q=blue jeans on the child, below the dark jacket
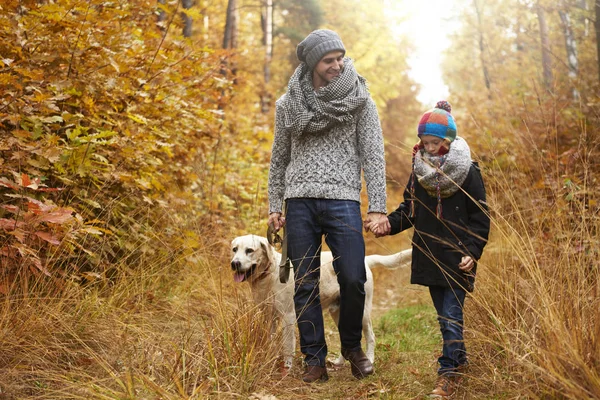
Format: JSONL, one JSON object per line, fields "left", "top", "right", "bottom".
{"left": 429, "top": 286, "right": 467, "bottom": 375}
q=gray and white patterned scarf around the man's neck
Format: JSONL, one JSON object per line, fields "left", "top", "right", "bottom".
{"left": 283, "top": 57, "right": 369, "bottom": 134}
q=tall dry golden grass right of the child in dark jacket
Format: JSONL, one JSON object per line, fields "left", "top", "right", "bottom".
{"left": 466, "top": 115, "right": 600, "bottom": 399}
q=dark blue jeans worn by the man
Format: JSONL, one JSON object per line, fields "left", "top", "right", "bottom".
{"left": 286, "top": 198, "right": 367, "bottom": 366}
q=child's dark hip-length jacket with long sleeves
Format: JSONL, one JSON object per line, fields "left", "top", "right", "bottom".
{"left": 388, "top": 163, "right": 490, "bottom": 291}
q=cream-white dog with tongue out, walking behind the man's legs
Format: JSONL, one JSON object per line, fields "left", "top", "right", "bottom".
{"left": 231, "top": 235, "right": 412, "bottom": 368}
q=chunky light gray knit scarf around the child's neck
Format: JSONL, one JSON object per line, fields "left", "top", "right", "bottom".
{"left": 414, "top": 137, "right": 471, "bottom": 198}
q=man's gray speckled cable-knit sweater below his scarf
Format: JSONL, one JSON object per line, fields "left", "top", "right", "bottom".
{"left": 269, "top": 94, "right": 386, "bottom": 213}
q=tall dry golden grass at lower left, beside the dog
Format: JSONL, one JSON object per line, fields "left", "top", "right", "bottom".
{"left": 0, "top": 217, "right": 286, "bottom": 399}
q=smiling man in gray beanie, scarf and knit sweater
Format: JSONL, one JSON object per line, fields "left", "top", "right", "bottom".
{"left": 269, "top": 29, "right": 386, "bottom": 382}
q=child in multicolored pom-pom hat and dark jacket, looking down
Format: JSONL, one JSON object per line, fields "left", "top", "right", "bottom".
{"left": 366, "top": 101, "right": 490, "bottom": 397}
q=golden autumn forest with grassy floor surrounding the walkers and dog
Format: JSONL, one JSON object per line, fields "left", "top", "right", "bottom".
{"left": 0, "top": 0, "right": 600, "bottom": 400}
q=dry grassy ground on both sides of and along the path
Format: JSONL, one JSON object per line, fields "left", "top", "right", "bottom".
{"left": 0, "top": 137, "right": 600, "bottom": 399}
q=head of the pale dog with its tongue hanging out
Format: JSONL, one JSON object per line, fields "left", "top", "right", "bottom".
{"left": 231, "top": 235, "right": 273, "bottom": 282}
